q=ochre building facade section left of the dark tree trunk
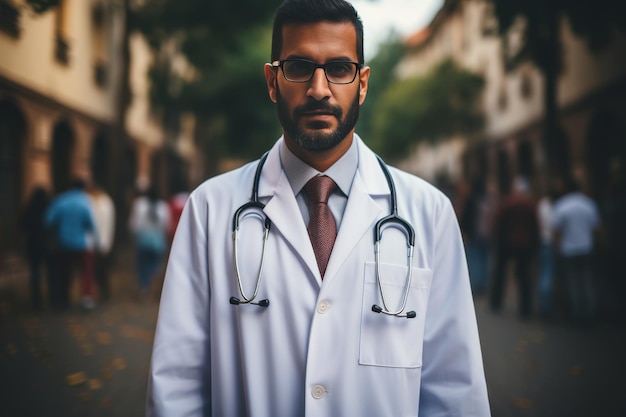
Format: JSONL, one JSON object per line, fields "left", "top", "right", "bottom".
{"left": 0, "top": 0, "right": 124, "bottom": 252}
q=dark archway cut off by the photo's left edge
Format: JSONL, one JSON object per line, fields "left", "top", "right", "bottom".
{"left": 0, "top": 100, "right": 26, "bottom": 253}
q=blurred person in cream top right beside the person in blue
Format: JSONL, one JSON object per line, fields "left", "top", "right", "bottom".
{"left": 89, "top": 184, "right": 115, "bottom": 300}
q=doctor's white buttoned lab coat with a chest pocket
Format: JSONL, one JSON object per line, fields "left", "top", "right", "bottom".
{"left": 148, "top": 135, "right": 490, "bottom": 417}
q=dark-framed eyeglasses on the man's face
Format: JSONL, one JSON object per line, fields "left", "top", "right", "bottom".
{"left": 272, "top": 59, "right": 363, "bottom": 84}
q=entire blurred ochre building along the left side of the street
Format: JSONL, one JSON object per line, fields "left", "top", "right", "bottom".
{"left": 0, "top": 0, "right": 203, "bottom": 262}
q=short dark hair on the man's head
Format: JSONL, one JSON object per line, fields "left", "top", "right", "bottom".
{"left": 271, "top": 0, "right": 365, "bottom": 64}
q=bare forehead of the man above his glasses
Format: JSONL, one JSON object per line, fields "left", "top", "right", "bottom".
{"left": 280, "top": 22, "right": 358, "bottom": 62}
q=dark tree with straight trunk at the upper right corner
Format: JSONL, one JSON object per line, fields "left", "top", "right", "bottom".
{"left": 491, "top": 0, "right": 626, "bottom": 176}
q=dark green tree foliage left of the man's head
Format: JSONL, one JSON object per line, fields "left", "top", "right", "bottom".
{"left": 132, "top": 0, "right": 280, "bottom": 158}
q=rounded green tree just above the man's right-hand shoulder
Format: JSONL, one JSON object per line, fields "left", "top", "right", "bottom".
{"left": 372, "top": 60, "right": 484, "bottom": 158}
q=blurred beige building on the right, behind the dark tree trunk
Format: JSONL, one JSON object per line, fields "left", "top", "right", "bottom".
{"left": 398, "top": 0, "right": 626, "bottom": 196}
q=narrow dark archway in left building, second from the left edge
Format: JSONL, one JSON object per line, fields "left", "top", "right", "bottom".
{"left": 52, "top": 121, "right": 75, "bottom": 194}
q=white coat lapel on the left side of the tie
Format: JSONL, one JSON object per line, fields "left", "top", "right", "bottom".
{"left": 259, "top": 140, "right": 321, "bottom": 284}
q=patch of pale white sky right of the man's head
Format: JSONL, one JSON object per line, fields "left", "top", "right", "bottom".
{"left": 351, "top": 0, "right": 443, "bottom": 60}
